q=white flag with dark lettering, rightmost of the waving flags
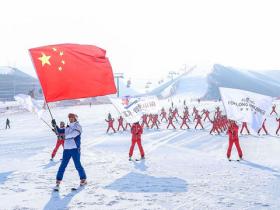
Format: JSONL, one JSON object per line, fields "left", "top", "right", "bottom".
{"left": 219, "top": 87, "right": 272, "bottom": 131}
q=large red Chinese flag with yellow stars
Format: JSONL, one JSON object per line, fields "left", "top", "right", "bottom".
{"left": 29, "top": 44, "right": 117, "bottom": 102}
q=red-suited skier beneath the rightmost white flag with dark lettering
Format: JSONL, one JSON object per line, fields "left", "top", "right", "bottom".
{"left": 227, "top": 120, "right": 243, "bottom": 161}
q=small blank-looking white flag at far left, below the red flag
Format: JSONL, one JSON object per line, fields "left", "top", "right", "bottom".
{"left": 14, "top": 94, "right": 45, "bottom": 119}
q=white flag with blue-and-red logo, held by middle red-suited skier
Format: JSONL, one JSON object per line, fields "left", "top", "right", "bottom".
{"left": 110, "top": 96, "right": 160, "bottom": 123}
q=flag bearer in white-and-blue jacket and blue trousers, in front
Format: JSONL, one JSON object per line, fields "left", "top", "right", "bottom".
{"left": 52, "top": 113, "right": 87, "bottom": 190}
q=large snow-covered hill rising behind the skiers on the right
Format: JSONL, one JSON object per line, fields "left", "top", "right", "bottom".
{"left": 143, "top": 64, "right": 280, "bottom": 100}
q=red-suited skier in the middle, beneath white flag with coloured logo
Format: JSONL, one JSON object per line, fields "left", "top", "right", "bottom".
{"left": 129, "top": 122, "right": 145, "bottom": 161}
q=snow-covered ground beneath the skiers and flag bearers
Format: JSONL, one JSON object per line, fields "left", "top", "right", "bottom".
{"left": 0, "top": 102, "right": 280, "bottom": 210}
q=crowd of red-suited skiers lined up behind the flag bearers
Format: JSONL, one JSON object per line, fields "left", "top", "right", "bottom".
{"left": 105, "top": 105, "right": 280, "bottom": 135}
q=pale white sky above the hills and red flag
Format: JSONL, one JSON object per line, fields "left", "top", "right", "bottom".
{"left": 0, "top": 0, "right": 280, "bottom": 82}
